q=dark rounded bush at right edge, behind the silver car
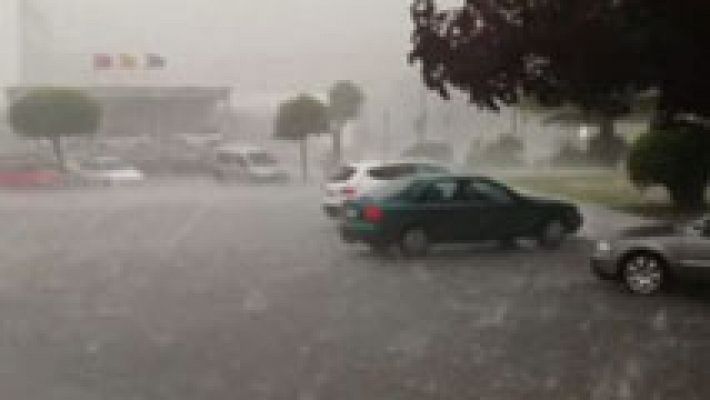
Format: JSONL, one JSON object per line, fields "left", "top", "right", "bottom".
{"left": 628, "top": 123, "right": 710, "bottom": 210}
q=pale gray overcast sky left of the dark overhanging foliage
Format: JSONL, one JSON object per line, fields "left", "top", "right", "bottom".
{"left": 33, "top": 0, "right": 464, "bottom": 98}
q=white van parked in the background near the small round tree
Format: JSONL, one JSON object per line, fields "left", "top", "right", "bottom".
{"left": 213, "top": 145, "right": 290, "bottom": 182}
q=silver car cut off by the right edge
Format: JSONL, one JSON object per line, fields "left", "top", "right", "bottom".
{"left": 591, "top": 217, "right": 710, "bottom": 295}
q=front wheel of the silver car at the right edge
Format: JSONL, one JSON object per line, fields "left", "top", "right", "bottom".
{"left": 621, "top": 253, "right": 666, "bottom": 295}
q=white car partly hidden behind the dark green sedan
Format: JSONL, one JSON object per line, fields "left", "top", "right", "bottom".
{"left": 323, "top": 160, "right": 450, "bottom": 218}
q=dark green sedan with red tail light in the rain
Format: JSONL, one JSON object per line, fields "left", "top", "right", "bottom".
{"left": 340, "top": 175, "right": 582, "bottom": 255}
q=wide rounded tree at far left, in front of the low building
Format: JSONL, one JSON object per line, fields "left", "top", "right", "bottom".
{"left": 8, "top": 88, "right": 101, "bottom": 169}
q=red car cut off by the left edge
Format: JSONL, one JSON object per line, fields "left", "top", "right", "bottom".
{"left": 0, "top": 159, "right": 64, "bottom": 188}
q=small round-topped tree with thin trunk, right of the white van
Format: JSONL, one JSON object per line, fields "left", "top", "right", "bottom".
{"left": 274, "top": 94, "right": 329, "bottom": 182}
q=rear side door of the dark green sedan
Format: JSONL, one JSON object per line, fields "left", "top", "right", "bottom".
{"left": 410, "top": 178, "right": 466, "bottom": 242}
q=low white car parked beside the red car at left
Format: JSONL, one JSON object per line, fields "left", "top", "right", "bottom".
{"left": 68, "top": 157, "right": 145, "bottom": 186}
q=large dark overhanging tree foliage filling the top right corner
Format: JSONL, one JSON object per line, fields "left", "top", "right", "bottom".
{"left": 410, "top": 0, "right": 710, "bottom": 163}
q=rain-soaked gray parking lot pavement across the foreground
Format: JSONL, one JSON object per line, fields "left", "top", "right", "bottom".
{"left": 0, "top": 180, "right": 710, "bottom": 400}
